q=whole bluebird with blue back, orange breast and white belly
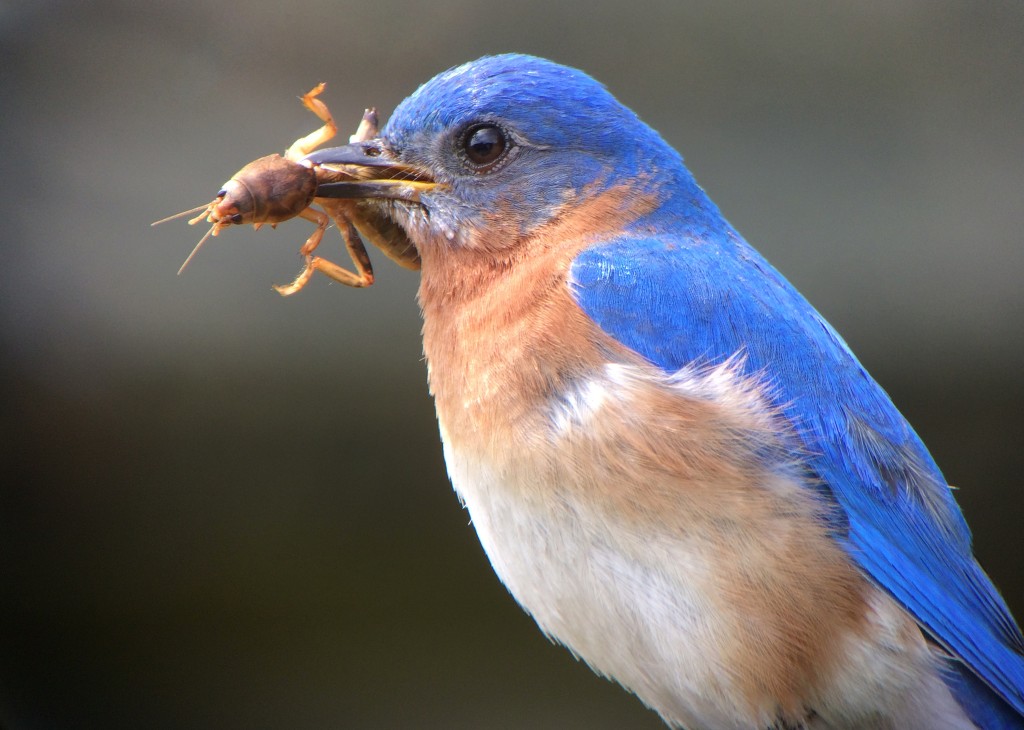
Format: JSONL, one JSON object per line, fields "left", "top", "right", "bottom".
{"left": 307, "top": 55, "right": 1024, "bottom": 730}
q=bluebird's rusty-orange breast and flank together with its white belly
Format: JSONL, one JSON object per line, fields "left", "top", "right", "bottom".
{"left": 413, "top": 241, "right": 880, "bottom": 728}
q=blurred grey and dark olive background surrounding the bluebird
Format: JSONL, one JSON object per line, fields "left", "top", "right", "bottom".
{"left": 0, "top": 0, "right": 1024, "bottom": 729}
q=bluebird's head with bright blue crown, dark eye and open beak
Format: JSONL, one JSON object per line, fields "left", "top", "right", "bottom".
{"left": 307, "top": 54, "right": 711, "bottom": 250}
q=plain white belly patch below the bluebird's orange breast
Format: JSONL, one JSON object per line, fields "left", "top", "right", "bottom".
{"left": 444, "top": 417, "right": 728, "bottom": 727}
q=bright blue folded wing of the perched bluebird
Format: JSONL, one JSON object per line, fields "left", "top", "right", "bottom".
{"left": 570, "top": 230, "right": 1024, "bottom": 726}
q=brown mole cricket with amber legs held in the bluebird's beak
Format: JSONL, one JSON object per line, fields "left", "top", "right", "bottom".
{"left": 152, "top": 83, "right": 420, "bottom": 296}
